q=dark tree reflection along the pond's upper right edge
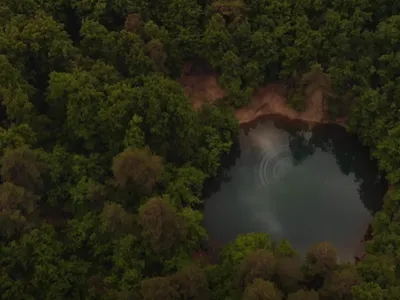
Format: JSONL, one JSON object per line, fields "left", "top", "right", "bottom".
{"left": 260, "top": 118, "right": 388, "bottom": 214}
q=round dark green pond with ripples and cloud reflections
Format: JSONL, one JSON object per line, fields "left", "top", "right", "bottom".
{"left": 205, "top": 118, "right": 387, "bottom": 260}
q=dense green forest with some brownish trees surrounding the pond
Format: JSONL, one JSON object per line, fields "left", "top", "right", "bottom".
{"left": 0, "top": 0, "right": 400, "bottom": 300}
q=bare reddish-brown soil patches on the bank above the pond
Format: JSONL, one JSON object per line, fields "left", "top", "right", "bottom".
{"left": 178, "top": 67, "right": 345, "bottom": 126}
